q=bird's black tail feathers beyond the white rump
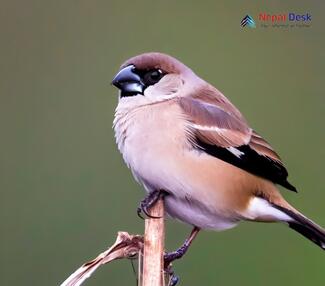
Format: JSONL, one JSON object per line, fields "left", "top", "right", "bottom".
{"left": 273, "top": 204, "right": 325, "bottom": 250}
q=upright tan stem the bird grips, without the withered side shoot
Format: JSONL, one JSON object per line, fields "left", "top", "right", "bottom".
{"left": 141, "top": 198, "right": 165, "bottom": 286}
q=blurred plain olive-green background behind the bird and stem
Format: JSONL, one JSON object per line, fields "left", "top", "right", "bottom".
{"left": 0, "top": 0, "right": 325, "bottom": 286}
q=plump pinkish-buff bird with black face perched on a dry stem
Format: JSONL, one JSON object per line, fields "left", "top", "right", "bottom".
{"left": 112, "top": 52, "right": 325, "bottom": 265}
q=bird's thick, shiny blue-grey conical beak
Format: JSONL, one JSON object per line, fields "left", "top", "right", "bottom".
{"left": 112, "top": 65, "right": 144, "bottom": 95}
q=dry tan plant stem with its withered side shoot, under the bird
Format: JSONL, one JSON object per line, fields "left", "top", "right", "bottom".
{"left": 60, "top": 198, "right": 165, "bottom": 286}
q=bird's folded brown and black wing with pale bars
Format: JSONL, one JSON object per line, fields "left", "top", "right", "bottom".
{"left": 178, "top": 93, "right": 296, "bottom": 191}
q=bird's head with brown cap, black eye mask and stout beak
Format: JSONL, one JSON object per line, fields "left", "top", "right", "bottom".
{"left": 112, "top": 53, "right": 195, "bottom": 101}
